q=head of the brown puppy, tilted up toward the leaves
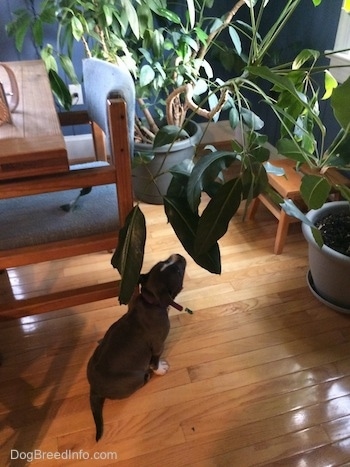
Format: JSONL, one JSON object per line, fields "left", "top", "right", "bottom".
{"left": 140, "top": 254, "right": 186, "bottom": 307}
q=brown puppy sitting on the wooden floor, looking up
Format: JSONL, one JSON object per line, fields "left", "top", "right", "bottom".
{"left": 87, "top": 254, "right": 186, "bottom": 441}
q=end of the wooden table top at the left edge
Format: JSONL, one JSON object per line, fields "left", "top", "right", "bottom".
{"left": 0, "top": 60, "right": 69, "bottom": 180}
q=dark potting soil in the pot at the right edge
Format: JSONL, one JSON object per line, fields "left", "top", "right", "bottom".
{"left": 316, "top": 212, "right": 350, "bottom": 256}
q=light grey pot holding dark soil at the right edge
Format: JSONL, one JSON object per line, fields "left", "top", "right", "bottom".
{"left": 302, "top": 201, "right": 350, "bottom": 313}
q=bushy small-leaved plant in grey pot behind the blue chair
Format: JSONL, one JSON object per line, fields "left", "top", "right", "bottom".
{"left": 7, "top": 0, "right": 242, "bottom": 203}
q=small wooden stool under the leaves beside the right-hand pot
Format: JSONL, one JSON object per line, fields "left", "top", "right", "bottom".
{"left": 248, "top": 159, "right": 302, "bottom": 255}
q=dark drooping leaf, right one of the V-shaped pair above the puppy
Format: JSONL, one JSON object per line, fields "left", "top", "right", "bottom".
{"left": 195, "top": 179, "right": 242, "bottom": 255}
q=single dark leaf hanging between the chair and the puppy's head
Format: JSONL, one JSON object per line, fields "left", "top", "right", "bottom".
{"left": 111, "top": 205, "right": 146, "bottom": 304}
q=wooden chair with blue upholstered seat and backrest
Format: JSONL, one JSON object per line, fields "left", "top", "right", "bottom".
{"left": 0, "top": 59, "right": 135, "bottom": 320}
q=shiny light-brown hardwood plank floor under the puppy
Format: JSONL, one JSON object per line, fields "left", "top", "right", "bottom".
{"left": 0, "top": 199, "right": 350, "bottom": 467}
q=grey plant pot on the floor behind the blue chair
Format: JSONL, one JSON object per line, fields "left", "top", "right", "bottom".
{"left": 133, "top": 121, "right": 202, "bottom": 204}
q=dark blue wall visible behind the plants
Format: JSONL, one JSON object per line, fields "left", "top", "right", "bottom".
{"left": 0, "top": 0, "right": 342, "bottom": 142}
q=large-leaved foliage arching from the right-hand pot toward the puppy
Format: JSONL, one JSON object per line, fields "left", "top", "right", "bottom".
{"left": 112, "top": 0, "right": 350, "bottom": 302}
